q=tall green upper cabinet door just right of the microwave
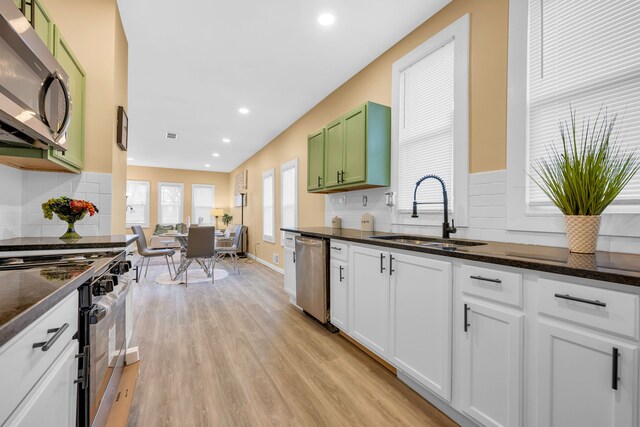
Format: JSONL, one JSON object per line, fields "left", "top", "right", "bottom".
{"left": 51, "top": 27, "right": 86, "bottom": 170}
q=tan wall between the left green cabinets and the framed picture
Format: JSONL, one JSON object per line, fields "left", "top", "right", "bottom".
{"left": 44, "top": 0, "right": 129, "bottom": 232}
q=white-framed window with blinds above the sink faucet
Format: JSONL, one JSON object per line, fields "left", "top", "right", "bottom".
{"left": 392, "top": 15, "right": 469, "bottom": 225}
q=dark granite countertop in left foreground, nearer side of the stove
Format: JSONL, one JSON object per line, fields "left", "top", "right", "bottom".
{"left": 0, "top": 263, "right": 94, "bottom": 346}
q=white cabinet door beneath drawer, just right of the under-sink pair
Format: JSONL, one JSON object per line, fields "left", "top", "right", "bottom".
{"left": 460, "top": 299, "right": 524, "bottom": 427}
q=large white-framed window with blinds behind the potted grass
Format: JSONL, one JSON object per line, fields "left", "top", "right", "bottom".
{"left": 507, "top": 0, "right": 640, "bottom": 234}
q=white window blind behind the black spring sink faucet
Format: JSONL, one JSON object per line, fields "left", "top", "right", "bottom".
{"left": 398, "top": 40, "right": 455, "bottom": 211}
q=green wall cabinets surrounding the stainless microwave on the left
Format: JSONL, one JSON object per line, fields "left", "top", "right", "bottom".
{"left": 0, "top": 0, "right": 86, "bottom": 173}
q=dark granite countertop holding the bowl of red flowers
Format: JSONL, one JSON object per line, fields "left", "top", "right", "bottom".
{"left": 0, "top": 234, "right": 136, "bottom": 256}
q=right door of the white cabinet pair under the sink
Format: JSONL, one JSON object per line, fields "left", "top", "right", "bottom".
{"left": 389, "top": 252, "right": 452, "bottom": 400}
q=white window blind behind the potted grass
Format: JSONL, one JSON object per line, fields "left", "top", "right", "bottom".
{"left": 527, "top": 0, "right": 640, "bottom": 206}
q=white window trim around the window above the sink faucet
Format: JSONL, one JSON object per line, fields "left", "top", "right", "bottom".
{"left": 391, "top": 14, "right": 470, "bottom": 227}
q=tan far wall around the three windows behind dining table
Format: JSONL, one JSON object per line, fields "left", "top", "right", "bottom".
{"left": 125, "top": 166, "right": 231, "bottom": 238}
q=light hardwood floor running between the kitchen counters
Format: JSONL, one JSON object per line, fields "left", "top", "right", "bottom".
{"left": 129, "top": 262, "right": 456, "bottom": 427}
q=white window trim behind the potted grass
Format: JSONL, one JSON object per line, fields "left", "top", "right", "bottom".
{"left": 506, "top": 0, "right": 640, "bottom": 237}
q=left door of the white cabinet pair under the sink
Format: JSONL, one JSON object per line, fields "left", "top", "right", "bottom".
{"left": 349, "top": 246, "right": 389, "bottom": 359}
